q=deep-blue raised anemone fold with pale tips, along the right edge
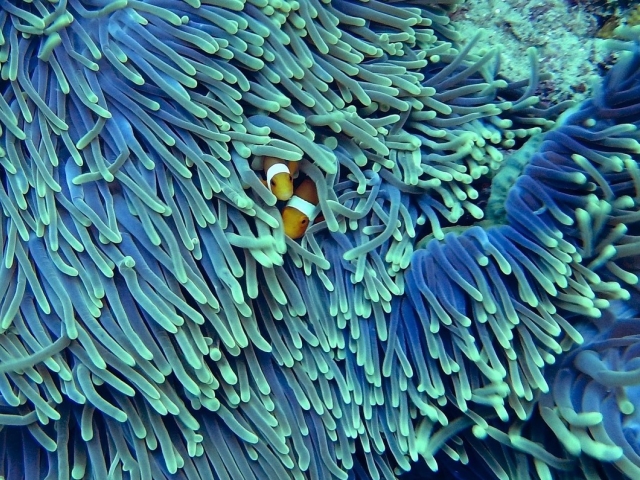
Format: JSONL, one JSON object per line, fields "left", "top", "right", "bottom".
{"left": 402, "top": 38, "right": 640, "bottom": 479}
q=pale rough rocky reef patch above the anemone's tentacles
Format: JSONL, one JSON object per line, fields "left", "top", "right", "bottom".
{"left": 452, "top": 0, "right": 611, "bottom": 102}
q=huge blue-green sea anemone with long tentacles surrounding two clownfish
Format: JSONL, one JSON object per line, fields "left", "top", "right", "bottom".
{"left": 0, "top": 0, "right": 640, "bottom": 480}
